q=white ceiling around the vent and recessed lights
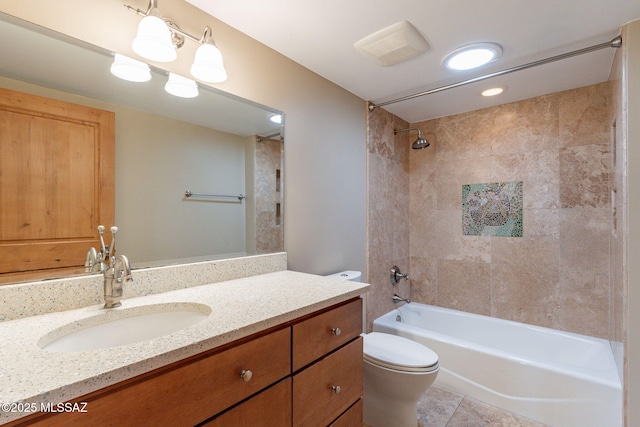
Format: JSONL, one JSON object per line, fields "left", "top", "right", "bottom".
{"left": 187, "top": 0, "right": 640, "bottom": 122}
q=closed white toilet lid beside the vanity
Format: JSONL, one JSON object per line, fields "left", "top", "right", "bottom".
{"left": 364, "top": 332, "right": 438, "bottom": 372}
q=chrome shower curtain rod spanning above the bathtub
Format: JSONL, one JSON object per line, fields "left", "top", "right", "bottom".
{"left": 369, "top": 36, "right": 622, "bottom": 111}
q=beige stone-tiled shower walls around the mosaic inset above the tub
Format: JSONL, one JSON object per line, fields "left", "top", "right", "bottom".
{"left": 368, "top": 83, "right": 612, "bottom": 338}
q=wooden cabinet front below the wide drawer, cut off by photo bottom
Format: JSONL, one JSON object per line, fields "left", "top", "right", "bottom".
{"left": 203, "top": 378, "right": 292, "bottom": 427}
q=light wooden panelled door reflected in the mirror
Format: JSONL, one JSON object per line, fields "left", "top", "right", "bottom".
{"left": 0, "top": 88, "right": 115, "bottom": 283}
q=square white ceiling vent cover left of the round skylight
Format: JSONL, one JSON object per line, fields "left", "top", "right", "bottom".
{"left": 354, "top": 21, "right": 431, "bottom": 67}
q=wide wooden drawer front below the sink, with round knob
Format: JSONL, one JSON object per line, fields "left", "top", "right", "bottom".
{"left": 20, "top": 327, "right": 291, "bottom": 427}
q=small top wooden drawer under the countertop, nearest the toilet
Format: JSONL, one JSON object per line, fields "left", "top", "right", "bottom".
{"left": 293, "top": 298, "right": 362, "bottom": 372}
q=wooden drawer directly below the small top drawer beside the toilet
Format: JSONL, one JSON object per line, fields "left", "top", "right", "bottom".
{"left": 293, "top": 337, "right": 362, "bottom": 427}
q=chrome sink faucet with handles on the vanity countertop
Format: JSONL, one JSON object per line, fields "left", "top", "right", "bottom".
{"left": 97, "top": 226, "right": 133, "bottom": 308}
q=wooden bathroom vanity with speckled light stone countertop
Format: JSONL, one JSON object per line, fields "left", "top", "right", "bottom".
{"left": 0, "top": 271, "right": 368, "bottom": 427}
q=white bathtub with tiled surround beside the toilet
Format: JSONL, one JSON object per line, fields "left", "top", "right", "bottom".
{"left": 373, "top": 303, "right": 622, "bottom": 427}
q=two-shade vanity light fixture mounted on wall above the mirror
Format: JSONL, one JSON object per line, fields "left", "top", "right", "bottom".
{"left": 125, "top": 0, "right": 227, "bottom": 83}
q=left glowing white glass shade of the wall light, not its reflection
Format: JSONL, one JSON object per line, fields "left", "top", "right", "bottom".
{"left": 131, "top": 15, "right": 178, "bottom": 62}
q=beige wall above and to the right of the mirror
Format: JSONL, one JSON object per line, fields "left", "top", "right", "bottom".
{"left": 0, "top": 0, "right": 366, "bottom": 274}
